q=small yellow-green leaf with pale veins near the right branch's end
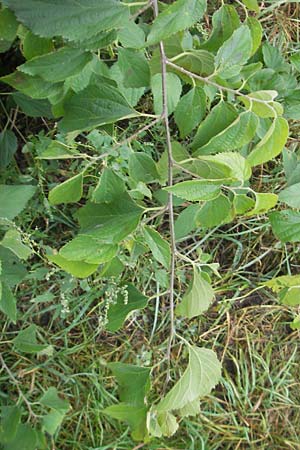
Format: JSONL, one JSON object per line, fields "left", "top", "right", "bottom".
{"left": 239, "top": 91, "right": 283, "bottom": 118}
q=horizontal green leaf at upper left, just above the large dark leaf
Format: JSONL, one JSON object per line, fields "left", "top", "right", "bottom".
{"left": 18, "top": 47, "right": 92, "bottom": 83}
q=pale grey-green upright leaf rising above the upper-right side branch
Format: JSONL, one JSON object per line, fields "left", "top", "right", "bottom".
{"left": 215, "top": 25, "right": 252, "bottom": 78}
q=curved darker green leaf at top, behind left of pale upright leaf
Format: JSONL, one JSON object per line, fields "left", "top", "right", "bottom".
{"left": 201, "top": 5, "right": 240, "bottom": 52}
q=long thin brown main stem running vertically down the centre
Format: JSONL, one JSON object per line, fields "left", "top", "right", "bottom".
{"left": 153, "top": 0, "right": 176, "bottom": 382}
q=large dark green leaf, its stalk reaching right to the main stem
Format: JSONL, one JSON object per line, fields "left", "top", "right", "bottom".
{"left": 60, "top": 80, "right": 139, "bottom": 133}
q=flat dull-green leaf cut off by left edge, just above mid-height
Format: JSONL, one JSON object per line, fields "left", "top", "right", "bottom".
{"left": 0, "top": 184, "right": 36, "bottom": 220}
